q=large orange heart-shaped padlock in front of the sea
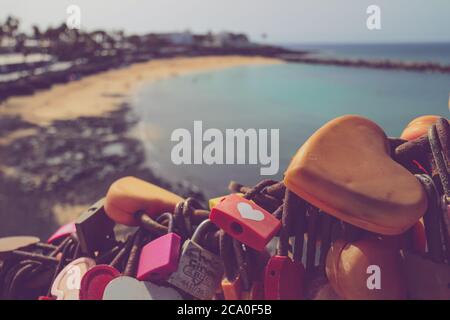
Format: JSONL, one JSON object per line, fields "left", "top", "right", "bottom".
{"left": 284, "top": 115, "right": 427, "bottom": 235}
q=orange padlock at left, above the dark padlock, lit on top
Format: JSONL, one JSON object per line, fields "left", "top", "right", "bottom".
{"left": 105, "top": 177, "right": 183, "bottom": 226}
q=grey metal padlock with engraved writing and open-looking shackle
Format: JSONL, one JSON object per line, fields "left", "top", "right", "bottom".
{"left": 167, "top": 220, "right": 224, "bottom": 300}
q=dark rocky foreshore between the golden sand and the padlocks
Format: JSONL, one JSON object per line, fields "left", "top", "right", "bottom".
{"left": 0, "top": 105, "right": 201, "bottom": 237}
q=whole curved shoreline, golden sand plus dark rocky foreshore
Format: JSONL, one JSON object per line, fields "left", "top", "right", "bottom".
{"left": 0, "top": 56, "right": 283, "bottom": 237}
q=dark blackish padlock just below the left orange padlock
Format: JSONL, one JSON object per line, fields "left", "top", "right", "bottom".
{"left": 75, "top": 199, "right": 115, "bottom": 257}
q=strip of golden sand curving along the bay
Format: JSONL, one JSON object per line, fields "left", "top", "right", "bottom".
{"left": 0, "top": 56, "right": 282, "bottom": 127}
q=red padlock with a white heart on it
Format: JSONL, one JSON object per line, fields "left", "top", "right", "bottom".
{"left": 210, "top": 194, "right": 281, "bottom": 251}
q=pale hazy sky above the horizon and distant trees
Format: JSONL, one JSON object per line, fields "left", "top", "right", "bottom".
{"left": 0, "top": 0, "right": 450, "bottom": 43}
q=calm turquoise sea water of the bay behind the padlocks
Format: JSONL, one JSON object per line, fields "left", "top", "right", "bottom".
{"left": 134, "top": 64, "right": 450, "bottom": 195}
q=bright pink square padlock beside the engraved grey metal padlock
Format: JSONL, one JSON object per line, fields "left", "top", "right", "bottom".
{"left": 136, "top": 212, "right": 181, "bottom": 281}
